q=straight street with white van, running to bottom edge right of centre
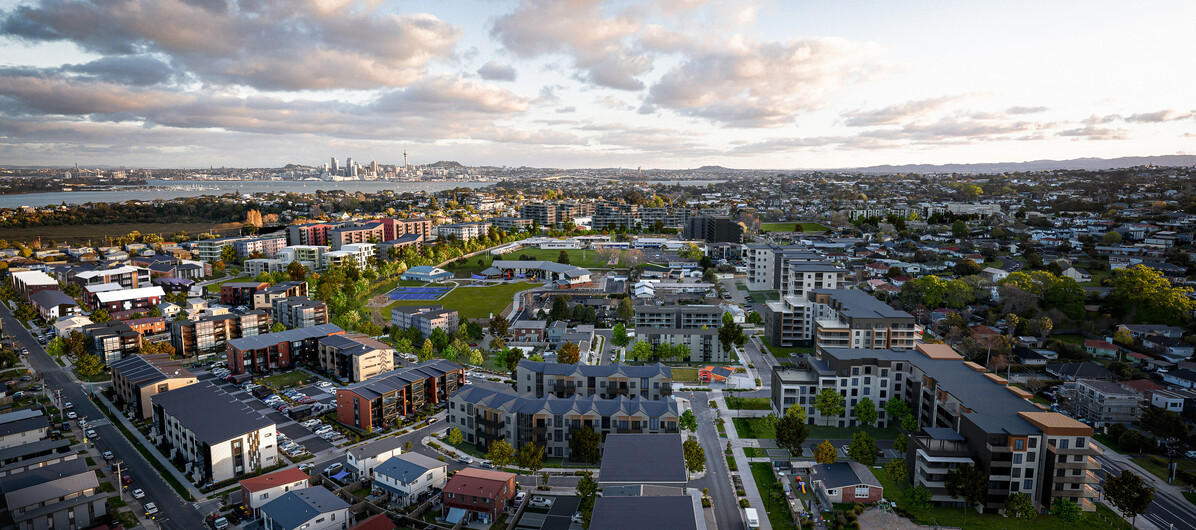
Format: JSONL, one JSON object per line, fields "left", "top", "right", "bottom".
{"left": 690, "top": 392, "right": 752, "bottom": 529}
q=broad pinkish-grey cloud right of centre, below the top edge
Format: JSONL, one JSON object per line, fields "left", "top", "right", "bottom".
{"left": 645, "top": 37, "right": 878, "bottom": 127}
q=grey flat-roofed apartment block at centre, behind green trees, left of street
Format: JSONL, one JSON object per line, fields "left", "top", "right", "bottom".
{"left": 634, "top": 304, "right": 731, "bottom": 363}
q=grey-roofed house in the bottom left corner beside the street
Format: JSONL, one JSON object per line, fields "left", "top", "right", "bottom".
{"left": 0, "top": 458, "right": 115, "bottom": 530}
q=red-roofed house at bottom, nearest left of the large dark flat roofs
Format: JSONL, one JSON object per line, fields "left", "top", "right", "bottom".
{"left": 440, "top": 468, "right": 515, "bottom": 524}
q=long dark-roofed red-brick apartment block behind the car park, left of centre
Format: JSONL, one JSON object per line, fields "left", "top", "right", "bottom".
{"left": 227, "top": 324, "right": 344, "bottom": 374}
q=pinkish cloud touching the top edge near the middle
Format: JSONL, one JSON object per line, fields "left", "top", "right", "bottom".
{"left": 490, "top": 0, "right": 652, "bottom": 90}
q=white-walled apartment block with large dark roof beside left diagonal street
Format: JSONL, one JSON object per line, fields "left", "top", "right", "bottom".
{"left": 150, "top": 380, "right": 279, "bottom": 483}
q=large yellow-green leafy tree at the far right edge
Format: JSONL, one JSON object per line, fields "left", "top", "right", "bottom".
{"left": 1112, "top": 264, "right": 1196, "bottom": 324}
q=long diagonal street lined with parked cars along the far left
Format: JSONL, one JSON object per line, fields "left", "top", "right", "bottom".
{"left": 0, "top": 304, "right": 218, "bottom": 529}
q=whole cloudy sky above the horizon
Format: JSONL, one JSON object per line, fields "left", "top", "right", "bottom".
{"left": 0, "top": 0, "right": 1196, "bottom": 169}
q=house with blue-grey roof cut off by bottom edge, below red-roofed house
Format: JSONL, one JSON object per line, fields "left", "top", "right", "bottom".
{"left": 261, "top": 486, "right": 353, "bottom": 530}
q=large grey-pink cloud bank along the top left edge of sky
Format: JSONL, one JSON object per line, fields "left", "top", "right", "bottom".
{"left": 0, "top": 0, "right": 462, "bottom": 91}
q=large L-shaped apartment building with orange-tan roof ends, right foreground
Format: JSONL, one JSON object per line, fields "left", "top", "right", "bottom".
{"left": 771, "top": 343, "right": 1099, "bottom": 511}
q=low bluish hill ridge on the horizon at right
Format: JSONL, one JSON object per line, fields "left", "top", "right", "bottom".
{"left": 853, "top": 154, "right": 1196, "bottom": 173}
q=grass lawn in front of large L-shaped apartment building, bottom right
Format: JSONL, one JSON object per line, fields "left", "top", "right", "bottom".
{"left": 874, "top": 473, "right": 1130, "bottom": 530}
